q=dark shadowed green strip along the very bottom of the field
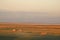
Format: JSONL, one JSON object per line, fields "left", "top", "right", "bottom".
{"left": 0, "top": 32, "right": 60, "bottom": 40}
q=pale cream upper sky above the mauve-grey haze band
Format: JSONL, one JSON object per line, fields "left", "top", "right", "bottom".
{"left": 0, "top": 0, "right": 60, "bottom": 12}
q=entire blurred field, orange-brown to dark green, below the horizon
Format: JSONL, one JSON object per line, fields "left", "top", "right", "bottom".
{"left": 0, "top": 23, "right": 60, "bottom": 40}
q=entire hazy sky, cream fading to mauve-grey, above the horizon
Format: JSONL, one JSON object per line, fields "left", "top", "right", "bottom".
{"left": 0, "top": 0, "right": 60, "bottom": 24}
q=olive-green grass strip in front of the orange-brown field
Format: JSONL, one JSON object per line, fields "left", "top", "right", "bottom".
{"left": 0, "top": 33, "right": 60, "bottom": 40}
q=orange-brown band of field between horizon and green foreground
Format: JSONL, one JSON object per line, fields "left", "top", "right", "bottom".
{"left": 0, "top": 23, "right": 60, "bottom": 35}
